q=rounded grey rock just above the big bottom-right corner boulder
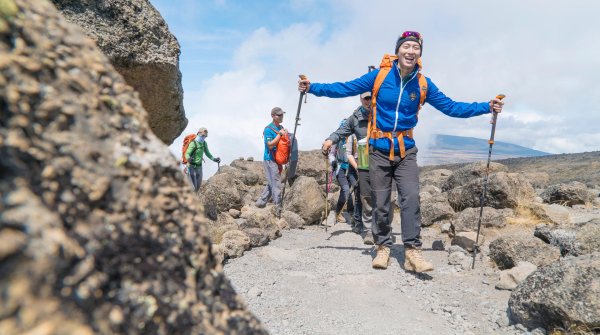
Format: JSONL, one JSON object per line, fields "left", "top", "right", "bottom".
{"left": 489, "top": 233, "right": 560, "bottom": 270}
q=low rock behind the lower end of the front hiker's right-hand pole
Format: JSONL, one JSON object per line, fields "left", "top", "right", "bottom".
{"left": 452, "top": 207, "right": 514, "bottom": 233}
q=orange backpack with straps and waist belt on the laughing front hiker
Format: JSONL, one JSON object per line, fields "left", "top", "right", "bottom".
{"left": 367, "top": 54, "right": 427, "bottom": 161}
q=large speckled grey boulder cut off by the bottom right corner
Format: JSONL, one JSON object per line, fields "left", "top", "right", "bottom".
{"left": 508, "top": 252, "right": 600, "bottom": 334}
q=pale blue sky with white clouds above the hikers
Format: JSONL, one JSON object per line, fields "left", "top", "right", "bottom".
{"left": 150, "top": 0, "right": 600, "bottom": 179}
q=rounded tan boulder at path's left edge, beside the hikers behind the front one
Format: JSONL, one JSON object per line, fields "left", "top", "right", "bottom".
{"left": 283, "top": 176, "right": 325, "bottom": 224}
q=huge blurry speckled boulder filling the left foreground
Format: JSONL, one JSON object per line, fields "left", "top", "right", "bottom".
{"left": 0, "top": 0, "right": 266, "bottom": 334}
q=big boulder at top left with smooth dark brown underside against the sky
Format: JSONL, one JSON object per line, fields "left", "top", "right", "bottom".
{"left": 52, "top": 0, "right": 188, "bottom": 144}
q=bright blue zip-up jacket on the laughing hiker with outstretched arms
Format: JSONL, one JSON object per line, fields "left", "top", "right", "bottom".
{"left": 308, "top": 61, "right": 490, "bottom": 153}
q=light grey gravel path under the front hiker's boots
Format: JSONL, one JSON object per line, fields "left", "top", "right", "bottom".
{"left": 224, "top": 216, "right": 527, "bottom": 334}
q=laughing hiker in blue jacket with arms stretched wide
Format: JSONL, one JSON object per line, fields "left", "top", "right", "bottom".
{"left": 298, "top": 31, "right": 503, "bottom": 272}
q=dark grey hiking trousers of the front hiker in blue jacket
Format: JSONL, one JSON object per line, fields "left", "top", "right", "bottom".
{"left": 369, "top": 147, "right": 422, "bottom": 247}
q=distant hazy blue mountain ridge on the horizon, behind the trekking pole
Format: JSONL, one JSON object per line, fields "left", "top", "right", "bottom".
{"left": 419, "top": 134, "right": 550, "bottom": 165}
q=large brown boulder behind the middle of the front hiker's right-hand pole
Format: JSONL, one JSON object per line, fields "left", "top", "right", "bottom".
{"left": 448, "top": 172, "right": 535, "bottom": 211}
